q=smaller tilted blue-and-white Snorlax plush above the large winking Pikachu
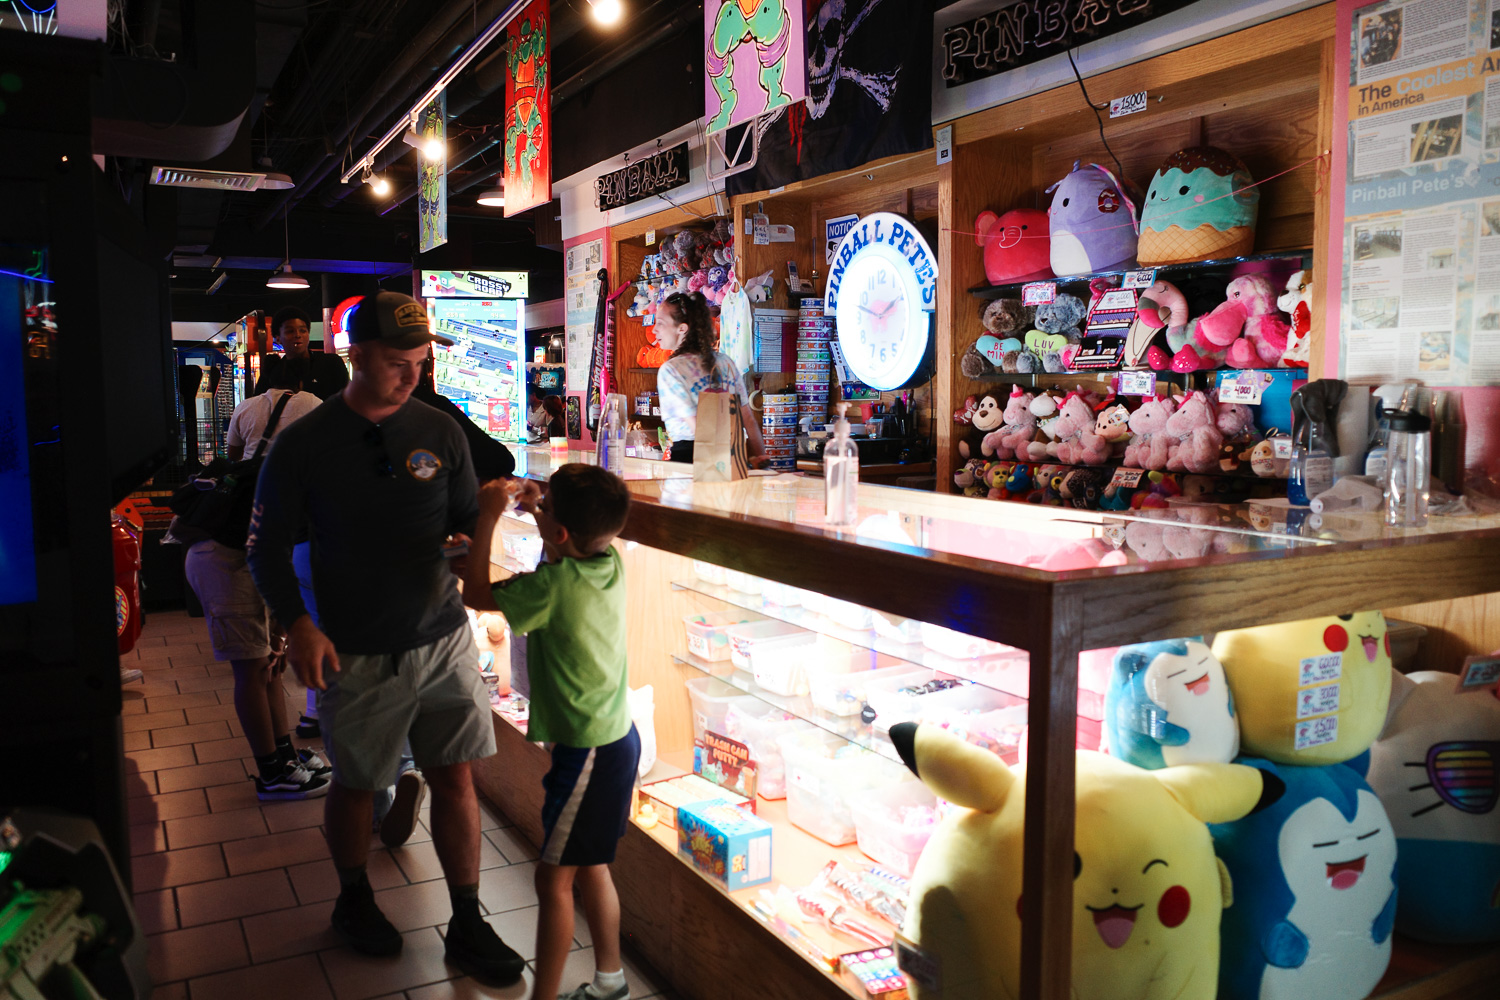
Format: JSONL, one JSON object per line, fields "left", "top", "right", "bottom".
{"left": 1104, "top": 639, "right": 1239, "bottom": 771}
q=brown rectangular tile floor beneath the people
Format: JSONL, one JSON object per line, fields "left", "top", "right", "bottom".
{"left": 123, "top": 612, "right": 660, "bottom": 1000}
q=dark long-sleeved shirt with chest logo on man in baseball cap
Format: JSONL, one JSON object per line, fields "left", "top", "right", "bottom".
{"left": 246, "top": 396, "right": 479, "bottom": 654}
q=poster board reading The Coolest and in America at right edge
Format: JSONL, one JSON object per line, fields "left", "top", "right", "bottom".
{"left": 1335, "top": 0, "right": 1500, "bottom": 385}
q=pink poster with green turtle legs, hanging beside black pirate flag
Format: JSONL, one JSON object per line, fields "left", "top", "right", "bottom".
{"left": 704, "top": 0, "right": 810, "bottom": 132}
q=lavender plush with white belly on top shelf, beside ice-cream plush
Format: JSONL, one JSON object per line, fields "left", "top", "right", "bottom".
{"left": 1047, "top": 160, "right": 1140, "bottom": 274}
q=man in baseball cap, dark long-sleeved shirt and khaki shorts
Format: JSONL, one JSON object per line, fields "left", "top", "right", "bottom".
{"left": 246, "top": 292, "right": 525, "bottom": 985}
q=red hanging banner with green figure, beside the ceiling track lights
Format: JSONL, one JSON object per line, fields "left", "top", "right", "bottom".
{"left": 506, "top": 0, "right": 552, "bottom": 219}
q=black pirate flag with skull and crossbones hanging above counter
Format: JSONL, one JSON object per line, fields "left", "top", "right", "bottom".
{"left": 725, "top": 0, "right": 933, "bottom": 195}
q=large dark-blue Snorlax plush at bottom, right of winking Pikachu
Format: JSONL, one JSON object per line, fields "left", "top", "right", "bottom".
{"left": 1209, "top": 757, "right": 1397, "bottom": 1000}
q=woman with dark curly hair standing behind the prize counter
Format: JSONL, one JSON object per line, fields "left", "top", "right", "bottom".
{"left": 656, "top": 292, "right": 765, "bottom": 466}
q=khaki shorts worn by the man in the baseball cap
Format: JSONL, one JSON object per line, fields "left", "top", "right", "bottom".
{"left": 318, "top": 622, "right": 495, "bottom": 790}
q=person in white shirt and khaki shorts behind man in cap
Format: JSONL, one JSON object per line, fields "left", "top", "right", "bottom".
{"left": 174, "top": 363, "right": 330, "bottom": 801}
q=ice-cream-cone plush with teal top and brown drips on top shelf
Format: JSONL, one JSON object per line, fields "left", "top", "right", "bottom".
{"left": 1136, "top": 145, "right": 1260, "bottom": 267}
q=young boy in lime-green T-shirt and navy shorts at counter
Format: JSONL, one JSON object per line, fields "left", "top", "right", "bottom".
{"left": 464, "top": 463, "right": 641, "bottom": 1000}
